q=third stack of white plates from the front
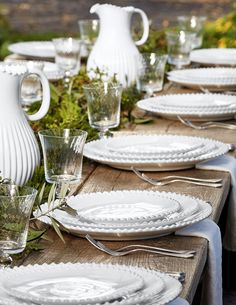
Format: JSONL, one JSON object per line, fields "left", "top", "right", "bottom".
{"left": 84, "top": 135, "right": 228, "bottom": 171}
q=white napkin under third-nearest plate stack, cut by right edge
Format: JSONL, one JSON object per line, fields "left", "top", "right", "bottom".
{"left": 196, "top": 155, "right": 236, "bottom": 251}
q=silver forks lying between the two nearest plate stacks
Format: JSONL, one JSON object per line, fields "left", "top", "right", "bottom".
{"left": 85, "top": 234, "right": 195, "bottom": 258}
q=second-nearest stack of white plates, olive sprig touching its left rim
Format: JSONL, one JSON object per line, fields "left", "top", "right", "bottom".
{"left": 34, "top": 190, "right": 212, "bottom": 240}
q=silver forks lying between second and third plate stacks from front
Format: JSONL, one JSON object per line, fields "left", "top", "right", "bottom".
{"left": 131, "top": 166, "right": 222, "bottom": 188}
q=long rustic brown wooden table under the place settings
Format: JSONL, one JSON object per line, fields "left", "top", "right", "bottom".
{"left": 18, "top": 84, "right": 235, "bottom": 303}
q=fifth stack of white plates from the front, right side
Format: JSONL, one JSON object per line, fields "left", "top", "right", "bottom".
{"left": 168, "top": 68, "right": 236, "bottom": 91}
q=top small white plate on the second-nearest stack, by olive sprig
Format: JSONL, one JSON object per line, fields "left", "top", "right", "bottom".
{"left": 60, "top": 191, "right": 180, "bottom": 224}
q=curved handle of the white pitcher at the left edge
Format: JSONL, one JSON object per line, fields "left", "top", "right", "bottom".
{"left": 26, "top": 67, "right": 50, "bottom": 121}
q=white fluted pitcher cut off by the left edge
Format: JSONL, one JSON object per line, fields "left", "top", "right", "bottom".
{"left": 0, "top": 63, "right": 50, "bottom": 185}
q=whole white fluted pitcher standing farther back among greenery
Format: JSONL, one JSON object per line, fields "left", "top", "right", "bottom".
{"left": 87, "top": 4, "right": 149, "bottom": 87}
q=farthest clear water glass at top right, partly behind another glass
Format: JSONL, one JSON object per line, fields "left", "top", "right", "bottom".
{"left": 177, "top": 16, "right": 206, "bottom": 49}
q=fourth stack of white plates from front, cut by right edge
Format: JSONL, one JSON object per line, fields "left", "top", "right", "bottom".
{"left": 137, "top": 93, "right": 236, "bottom": 121}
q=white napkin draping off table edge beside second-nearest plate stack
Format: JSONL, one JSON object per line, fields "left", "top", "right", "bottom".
{"left": 175, "top": 218, "right": 223, "bottom": 305}
